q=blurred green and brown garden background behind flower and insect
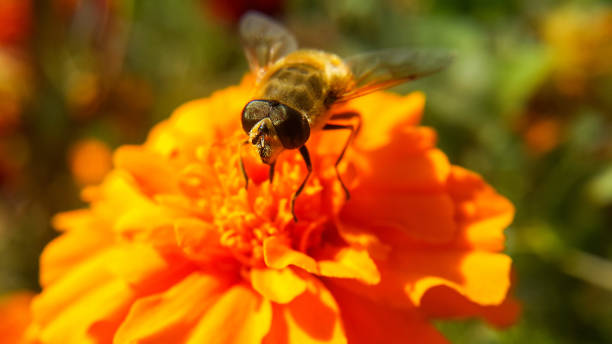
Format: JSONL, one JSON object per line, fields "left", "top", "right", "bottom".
{"left": 0, "top": 0, "right": 612, "bottom": 343}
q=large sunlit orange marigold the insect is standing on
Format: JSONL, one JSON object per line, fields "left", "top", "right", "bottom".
{"left": 29, "top": 78, "right": 516, "bottom": 344}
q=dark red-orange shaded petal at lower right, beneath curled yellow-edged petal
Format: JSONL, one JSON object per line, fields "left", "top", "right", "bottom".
{"left": 420, "top": 286, "right": 521, "bottom": 327}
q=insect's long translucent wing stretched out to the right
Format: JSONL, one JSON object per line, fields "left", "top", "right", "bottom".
{"left": 338, "top": 48, "right": 453, "bottom": 101}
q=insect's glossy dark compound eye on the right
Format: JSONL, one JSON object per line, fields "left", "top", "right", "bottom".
{"left": 270, "top": 104, "right": 310, "bottom": 149}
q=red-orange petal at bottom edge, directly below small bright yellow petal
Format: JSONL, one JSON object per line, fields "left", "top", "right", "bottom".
{"left": 262, "top": 279, "right": 346, "bottom": 344}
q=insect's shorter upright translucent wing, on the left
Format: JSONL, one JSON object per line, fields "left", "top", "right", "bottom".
{"left": 240, "top": 12, "right": 297, "bottom": 74}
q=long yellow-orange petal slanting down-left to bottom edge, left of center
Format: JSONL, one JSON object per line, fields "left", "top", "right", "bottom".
{"left": 114, "top": 272, "right": 227, "bottom": 343}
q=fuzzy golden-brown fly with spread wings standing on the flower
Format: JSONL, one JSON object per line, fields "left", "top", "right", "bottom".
{"left": 240, "top": 12, "right": 451, "bottom": 222}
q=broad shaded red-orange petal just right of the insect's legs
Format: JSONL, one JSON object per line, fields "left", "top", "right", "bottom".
{"left": 340, "top": 122, "right": 457, "bottom": 246}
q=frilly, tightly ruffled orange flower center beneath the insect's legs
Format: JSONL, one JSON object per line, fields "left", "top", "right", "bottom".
{"left": 176, "top": 132, "right": 343, "bottom": 266}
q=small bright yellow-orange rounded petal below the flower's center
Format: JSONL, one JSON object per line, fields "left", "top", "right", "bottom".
{"left": 251, "top": 268, "right": 306, "bottom": 303}
